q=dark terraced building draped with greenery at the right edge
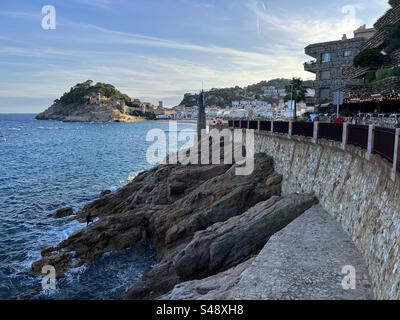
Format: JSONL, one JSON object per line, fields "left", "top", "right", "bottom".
{"left": 345, "top": 0, "right": 400, "bottom": 113}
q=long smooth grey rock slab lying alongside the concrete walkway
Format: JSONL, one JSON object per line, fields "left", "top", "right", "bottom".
{"left": 174, "top": 194, "right": 317, "bottom": 279}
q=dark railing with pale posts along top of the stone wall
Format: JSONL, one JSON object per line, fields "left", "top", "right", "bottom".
{"left": 228, "top": 120, "right": 400, "bottom": 180}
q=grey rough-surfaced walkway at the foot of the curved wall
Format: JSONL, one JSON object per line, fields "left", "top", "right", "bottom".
{"left": 227, "top": 206, "right": 374, "bottom": 300}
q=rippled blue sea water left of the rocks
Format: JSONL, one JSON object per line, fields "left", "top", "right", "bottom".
{"left": 0, "top": 114, "right": 195, "bottom": 299}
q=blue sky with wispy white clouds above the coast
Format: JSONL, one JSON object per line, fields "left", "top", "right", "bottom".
{"left": 0, "top": 0, "right": 389, "bottom": 113}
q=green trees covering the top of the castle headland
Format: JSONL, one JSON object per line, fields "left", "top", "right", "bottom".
{"left": 54, "top": 80, "right": 131, "bottom": 105}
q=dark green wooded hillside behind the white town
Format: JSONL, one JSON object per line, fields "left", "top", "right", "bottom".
{"left": 180, "top": 79, "right": 290, "bottom": 108}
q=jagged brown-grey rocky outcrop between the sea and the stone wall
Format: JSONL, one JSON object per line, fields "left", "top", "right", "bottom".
{"left": 32, "top": 141, "right": 324, "bottom": 299}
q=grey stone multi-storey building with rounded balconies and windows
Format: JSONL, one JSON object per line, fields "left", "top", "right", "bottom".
{"left": 304, "top": 26, "right": 375, "bottom": 106}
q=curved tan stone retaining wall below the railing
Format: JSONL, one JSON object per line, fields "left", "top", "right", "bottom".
{"left": 250, "top": 133, "right": 400, "bottom": 299}
